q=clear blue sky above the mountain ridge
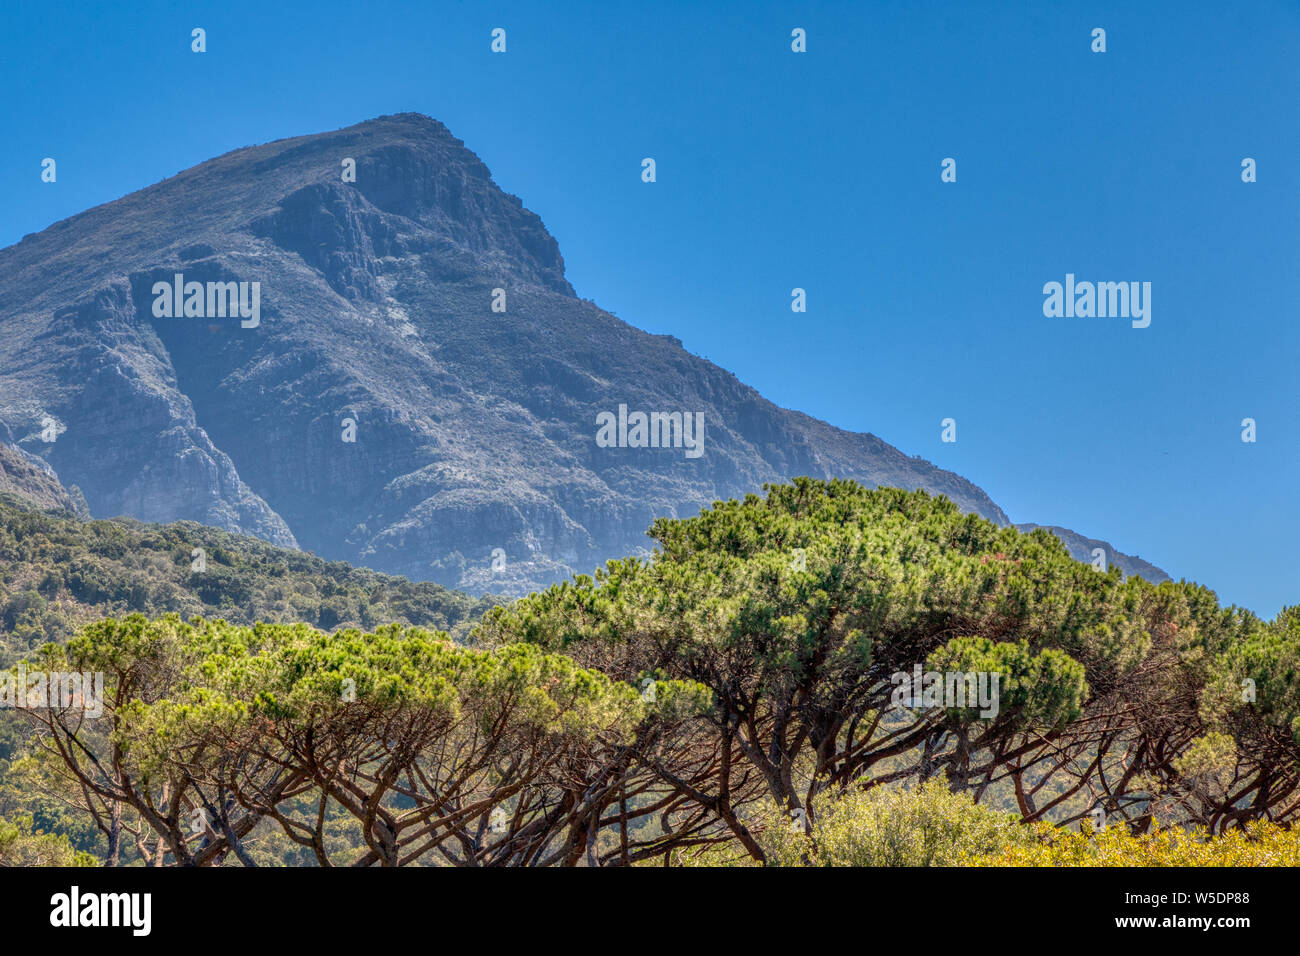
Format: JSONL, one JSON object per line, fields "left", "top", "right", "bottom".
{"left": 0, "top": 0, "right": 1300, "bottom": 615}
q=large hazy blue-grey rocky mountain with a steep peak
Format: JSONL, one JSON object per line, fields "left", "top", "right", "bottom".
{"left": 0, "top": 113, "right": 1170, "bottom": 593}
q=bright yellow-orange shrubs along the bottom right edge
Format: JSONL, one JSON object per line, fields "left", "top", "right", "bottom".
{"left": 962, "top": 821, "right": 1300, "bottom": 866}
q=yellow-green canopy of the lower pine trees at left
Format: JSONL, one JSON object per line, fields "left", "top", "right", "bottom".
{"left": 42, "top": 614, "right": 707, "bottom": 773}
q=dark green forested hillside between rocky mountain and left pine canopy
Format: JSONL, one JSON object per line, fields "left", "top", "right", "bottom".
{"left": 0, "top": 494, "right": 493, "bottom": 663}
